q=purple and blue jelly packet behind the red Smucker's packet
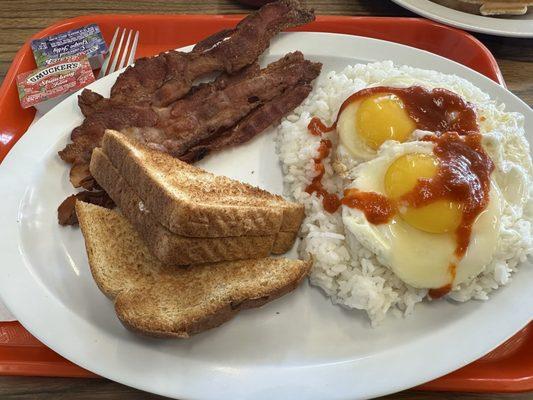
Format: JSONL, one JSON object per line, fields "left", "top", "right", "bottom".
{"left": 31, "top": 24, "right": 108, "bottom": 69}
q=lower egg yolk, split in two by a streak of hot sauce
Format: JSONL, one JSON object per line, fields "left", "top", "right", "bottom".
{"left": 385, "top": 153, "right": 462, "bottom": 233}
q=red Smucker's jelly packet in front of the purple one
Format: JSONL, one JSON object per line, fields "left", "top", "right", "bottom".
{"left": 17, "top": 54, "right": 94, "bottom": 108}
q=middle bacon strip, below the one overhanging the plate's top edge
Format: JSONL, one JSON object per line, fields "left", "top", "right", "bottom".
{"left": 59, "top": 52, "right": 321, "bottom": 163}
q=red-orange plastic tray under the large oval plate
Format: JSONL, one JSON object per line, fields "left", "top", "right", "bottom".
{"left": 0, "top": 15, "right": 533, "bottom": 392}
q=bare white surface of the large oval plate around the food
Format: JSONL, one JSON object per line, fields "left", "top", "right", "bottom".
{"left": 0, "top": 33, "right": 533, "bottom": 400}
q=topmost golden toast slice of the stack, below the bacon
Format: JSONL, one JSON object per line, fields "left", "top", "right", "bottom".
{"left": 102, "top": 130, "right": 304, "bottom": 237}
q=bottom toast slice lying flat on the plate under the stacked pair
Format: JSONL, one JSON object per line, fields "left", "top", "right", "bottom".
{"left": 76, "top": 201, "right": 311, "bottom": 338}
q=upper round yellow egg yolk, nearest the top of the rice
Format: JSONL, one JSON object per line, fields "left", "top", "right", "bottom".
{"left": 356, "top": 93, "right": 416, "bottom": 150}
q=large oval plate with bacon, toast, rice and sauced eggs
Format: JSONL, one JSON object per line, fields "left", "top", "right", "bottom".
{"left": 0, "top": 1, "right": 533, "bottom": 399}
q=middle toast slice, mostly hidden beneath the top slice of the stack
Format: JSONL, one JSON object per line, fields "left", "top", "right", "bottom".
{"left": 91, "top": 148, "right": 276, "bottom": 265}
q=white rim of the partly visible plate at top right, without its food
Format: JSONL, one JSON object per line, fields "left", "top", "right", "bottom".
{"left": 392, "top": 0, "right": 533, "bottom": 38}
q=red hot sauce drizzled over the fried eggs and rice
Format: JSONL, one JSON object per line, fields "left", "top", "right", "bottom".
{"left": 306, "top": 86, "right": 494, "bottom": 299}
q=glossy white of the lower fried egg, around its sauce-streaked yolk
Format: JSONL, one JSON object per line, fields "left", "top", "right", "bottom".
{"left": 342, "top": 142, "right": 501, "bottom": 288}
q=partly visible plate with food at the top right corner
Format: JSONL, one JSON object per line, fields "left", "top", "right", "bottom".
{"left": 392, "top": 0, "right": 533, "bottom": 38}
